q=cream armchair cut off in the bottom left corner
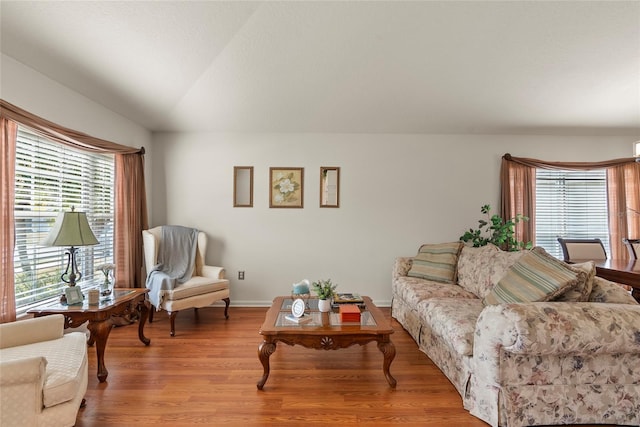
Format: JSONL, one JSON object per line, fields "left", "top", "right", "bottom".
{"left": 0, "top": 314, "right": 88, "bottom": 427}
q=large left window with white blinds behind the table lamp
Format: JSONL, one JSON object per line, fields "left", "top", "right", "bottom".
{"left": 14, "top": 127, "right": 115, "bottom": 314}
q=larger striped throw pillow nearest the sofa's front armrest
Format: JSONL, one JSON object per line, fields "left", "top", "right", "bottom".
{"left": 482, "top": 247, "right": 586, "bottom": 305}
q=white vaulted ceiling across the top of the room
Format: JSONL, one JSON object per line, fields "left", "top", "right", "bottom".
{"left": 0, "top": 0, "right": 640, "bottom": 136}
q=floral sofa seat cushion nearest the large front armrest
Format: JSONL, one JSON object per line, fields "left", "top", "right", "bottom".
{"left": 418, "top": 298, "right": 484, "bottom": 356}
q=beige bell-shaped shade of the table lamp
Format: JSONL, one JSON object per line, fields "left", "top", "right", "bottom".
{"left": 42, "top": 208, "right": 98, "bottom": 246}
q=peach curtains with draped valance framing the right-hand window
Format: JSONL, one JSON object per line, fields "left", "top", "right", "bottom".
{"left": 500, "top": 153, "right": 640, "bottom": 259}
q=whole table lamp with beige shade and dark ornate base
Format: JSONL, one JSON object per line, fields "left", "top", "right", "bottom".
{"left": 42, "top": 206, "right": 98, "bottom": 288}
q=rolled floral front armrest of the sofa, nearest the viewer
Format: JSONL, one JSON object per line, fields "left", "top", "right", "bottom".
{"left": 473, "top": 302, "right": 640, "bottom": 380}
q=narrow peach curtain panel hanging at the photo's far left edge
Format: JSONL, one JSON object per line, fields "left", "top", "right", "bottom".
{"left": 0, "top": 117, "right": 18, "bottom": 323}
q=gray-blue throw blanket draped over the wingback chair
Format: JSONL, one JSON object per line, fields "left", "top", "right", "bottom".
{"left": 146, "top": 225, "right": 198, "bottom": 310}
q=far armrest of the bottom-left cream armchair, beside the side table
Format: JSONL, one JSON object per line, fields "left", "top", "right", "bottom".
{"left": 0, "top": 314, "right": 64, "bottom": 348}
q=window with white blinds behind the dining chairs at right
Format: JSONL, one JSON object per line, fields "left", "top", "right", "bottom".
{"left": 536, "top": 169, "right": 611, "bottom": 259}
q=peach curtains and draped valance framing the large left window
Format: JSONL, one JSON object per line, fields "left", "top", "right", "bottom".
{"left": 0, "top": 99, "right": 147, "bottom": 321}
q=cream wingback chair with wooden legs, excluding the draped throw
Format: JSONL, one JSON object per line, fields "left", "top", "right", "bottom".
{"left": 142, "top": 226, "right": 230, "bottom": 336}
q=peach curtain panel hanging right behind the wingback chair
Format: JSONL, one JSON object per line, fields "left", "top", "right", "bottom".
{"left": 115, "top": 154, "right": 149, "bottom": 288}
